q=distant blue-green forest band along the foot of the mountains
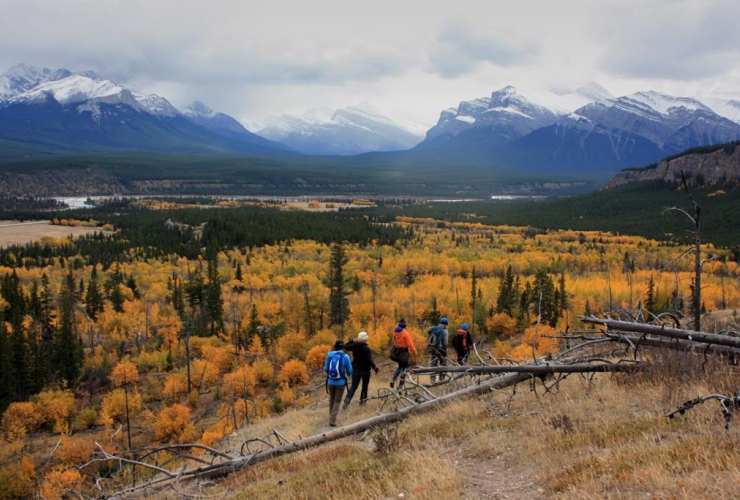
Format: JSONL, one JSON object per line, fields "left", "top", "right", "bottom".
{"left": 0, "top": 153, "right": 604, "bottom": 196}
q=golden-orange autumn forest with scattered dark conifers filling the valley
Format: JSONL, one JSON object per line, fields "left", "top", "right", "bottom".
{"left": 0, "top": 200, "right": 740, "bottom": 498}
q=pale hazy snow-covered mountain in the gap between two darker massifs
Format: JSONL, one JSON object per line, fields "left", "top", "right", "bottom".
{"left": 257, "top": 102, "right": 424, "bottom": 155}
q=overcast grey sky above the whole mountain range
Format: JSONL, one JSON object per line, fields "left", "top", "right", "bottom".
{"left": 0, "top": 0, "right": 740, "bottom": 127}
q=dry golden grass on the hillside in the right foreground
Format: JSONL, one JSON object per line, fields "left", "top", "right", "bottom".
{"left": 215, "top": 354, "right": 740, "bottom": 499}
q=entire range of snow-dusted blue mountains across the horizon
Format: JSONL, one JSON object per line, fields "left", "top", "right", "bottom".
{"left": 0, "top": 64, "right": 740, "bottom": 178}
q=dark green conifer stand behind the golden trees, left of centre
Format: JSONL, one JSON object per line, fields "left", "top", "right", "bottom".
{"left": 0, "top": 199, "right": 412, "bottom": 268}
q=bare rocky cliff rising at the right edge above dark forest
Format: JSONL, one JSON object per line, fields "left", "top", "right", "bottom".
{"left": 602, "top": 142, "right": 740, "bottom": 189}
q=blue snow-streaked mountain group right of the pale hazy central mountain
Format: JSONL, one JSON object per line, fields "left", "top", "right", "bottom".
{"left": 407, "top": 83, "right": 740, "bottom": 175}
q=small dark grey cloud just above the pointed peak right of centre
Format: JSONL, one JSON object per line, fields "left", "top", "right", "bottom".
{"left": 429, "top": 27, "right": 541, "bottom": 78}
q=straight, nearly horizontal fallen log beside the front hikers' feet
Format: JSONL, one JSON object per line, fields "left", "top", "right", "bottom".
{"left": 410, "top": 362, "right": 646, "bottom": 376}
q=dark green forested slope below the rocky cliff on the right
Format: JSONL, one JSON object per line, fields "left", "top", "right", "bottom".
{"left": 376, "top": 182, "right": 740, "bottom": 252}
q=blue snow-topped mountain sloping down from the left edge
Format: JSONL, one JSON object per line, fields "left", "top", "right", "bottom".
{"left": 0, "top": 65, "right": 287, "bottom": 155}
